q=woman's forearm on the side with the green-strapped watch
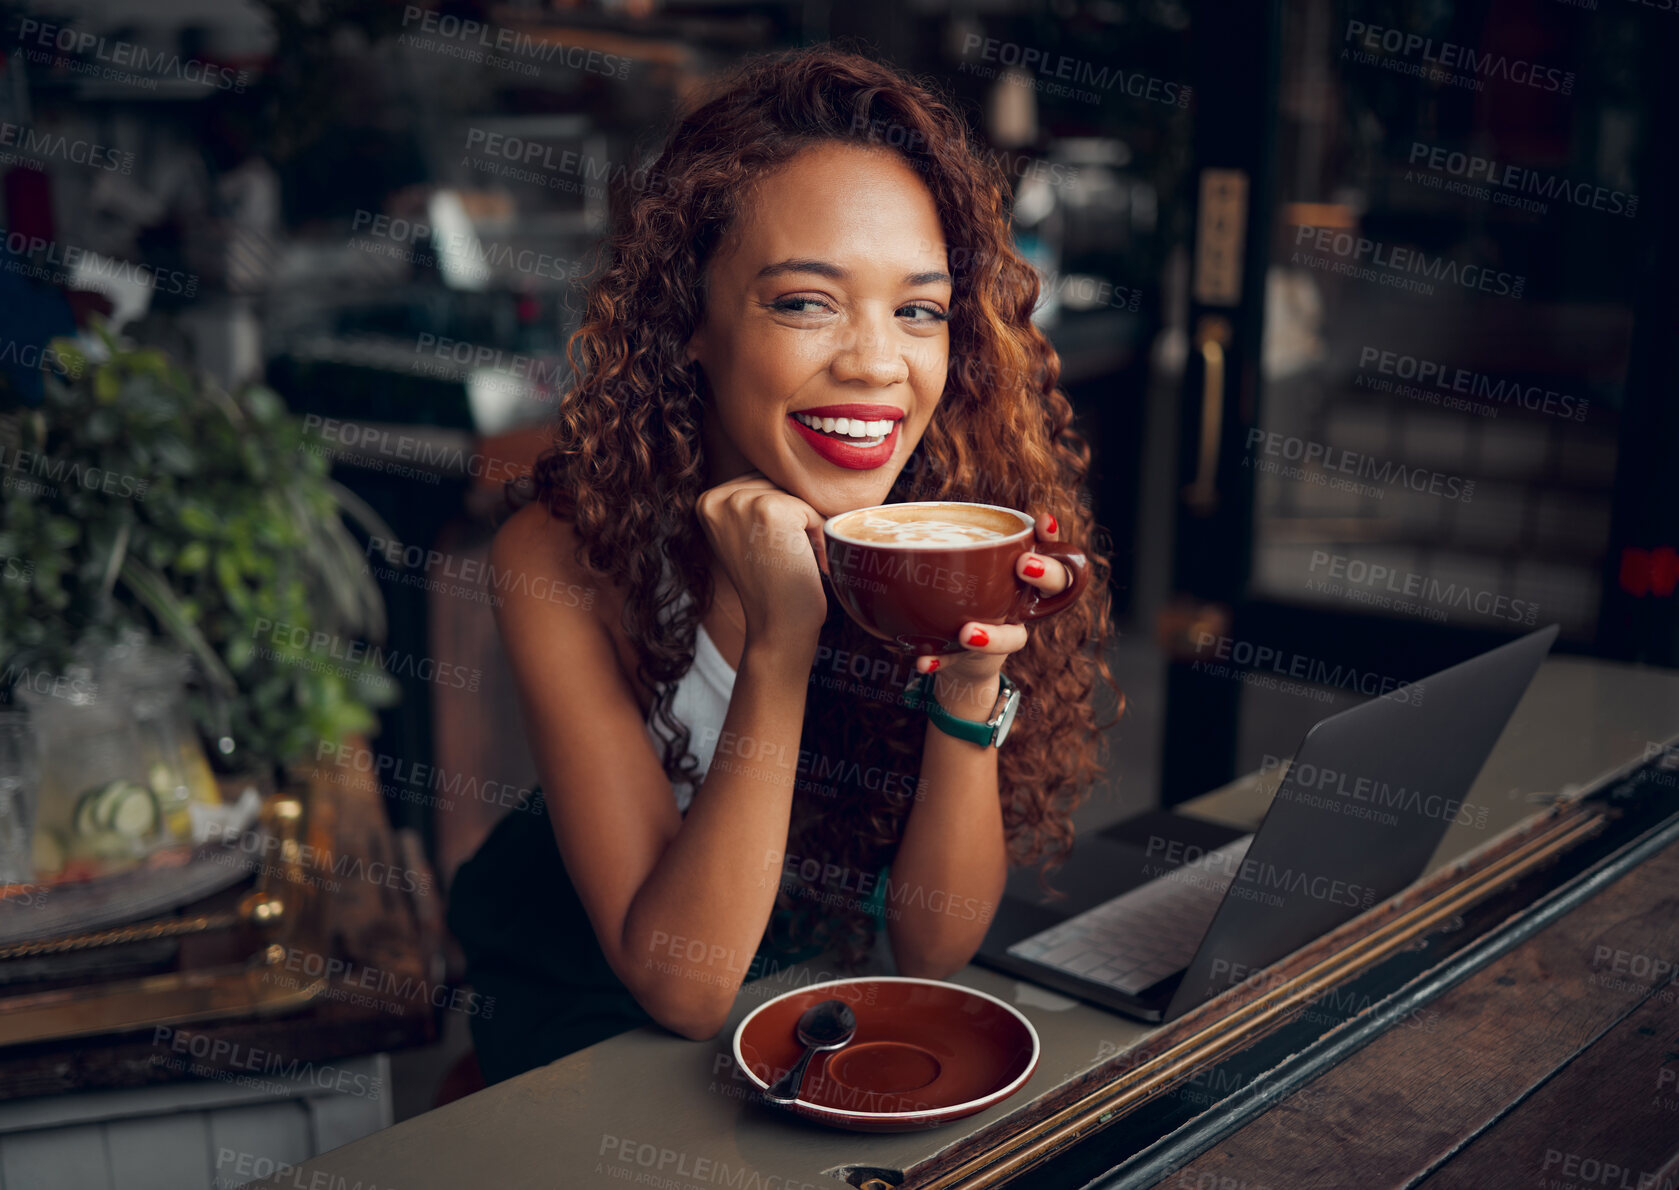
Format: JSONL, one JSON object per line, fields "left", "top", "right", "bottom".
{"left": 885, "top": 675, "right": 1007, "bottom": 979}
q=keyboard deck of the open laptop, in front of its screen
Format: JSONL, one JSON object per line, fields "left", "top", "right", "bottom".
{"left": 1009, "top": 834, "right": 1253, "bottom": 995}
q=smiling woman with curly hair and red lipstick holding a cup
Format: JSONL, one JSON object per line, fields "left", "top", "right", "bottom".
{"left": 450, "top": 47, "right": 1123, "bottom": 1081}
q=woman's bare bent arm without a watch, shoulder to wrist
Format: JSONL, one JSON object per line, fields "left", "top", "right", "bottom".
{"left": 490, "top": 505, "right": 819, "bottom": 1039}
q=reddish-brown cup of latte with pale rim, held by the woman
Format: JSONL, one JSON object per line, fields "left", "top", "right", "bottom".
{"left": 823, "top": 500, "right": 1090, "bottom": 656}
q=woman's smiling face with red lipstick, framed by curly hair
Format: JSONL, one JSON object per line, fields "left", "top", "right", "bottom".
{"left": 688, "top": 144, "right": 952, "bottom": 517}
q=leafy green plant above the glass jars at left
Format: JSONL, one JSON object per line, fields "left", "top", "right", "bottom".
{"left": 0, "top": 331, "right": 398, "bottom": 788}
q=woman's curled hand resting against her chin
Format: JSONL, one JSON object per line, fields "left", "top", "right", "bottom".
{"left": 695, "top": 472, "right": 828, "bottom": 655}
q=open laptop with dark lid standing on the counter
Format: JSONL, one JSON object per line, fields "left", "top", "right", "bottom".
{"left": 979, "top": 624, "right": 1558, "bottom": 1020}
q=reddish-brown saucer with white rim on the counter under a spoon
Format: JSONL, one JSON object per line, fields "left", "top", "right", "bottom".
{"left": 734, "top": 975, "right": 1038, "bottom": 1133}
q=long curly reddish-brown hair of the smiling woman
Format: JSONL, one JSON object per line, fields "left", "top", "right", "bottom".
{"left": 512, "top": 45, "right": 1125, "bottom": 963}
